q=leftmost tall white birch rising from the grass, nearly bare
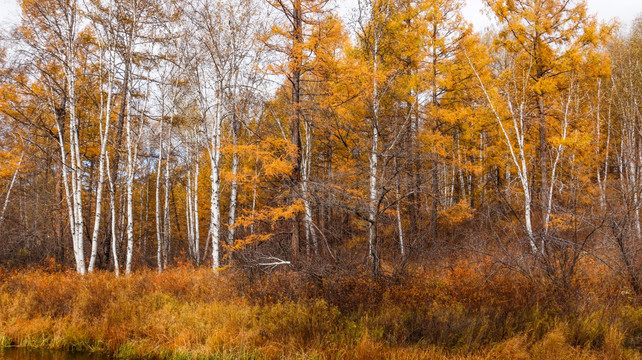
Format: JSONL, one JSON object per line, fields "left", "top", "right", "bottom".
{"left": 19, "top": 0, "right": 86, "bottom": 274}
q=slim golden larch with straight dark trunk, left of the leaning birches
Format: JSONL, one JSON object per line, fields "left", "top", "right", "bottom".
{"left": 412, "top": 1, "right": 470, "bottom": 245}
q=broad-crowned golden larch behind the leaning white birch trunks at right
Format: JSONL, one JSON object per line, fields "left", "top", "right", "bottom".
{"left": 486, "top": 0, "right": 609, "bottom": 251}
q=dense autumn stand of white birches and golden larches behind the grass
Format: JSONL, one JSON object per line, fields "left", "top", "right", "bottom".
{"left": 0, "top": 0, "right": 642, "bottom": 293}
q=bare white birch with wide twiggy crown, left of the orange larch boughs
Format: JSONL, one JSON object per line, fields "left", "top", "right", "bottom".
{"left": 191, "top": 0, "right": 264, "bottom": 270}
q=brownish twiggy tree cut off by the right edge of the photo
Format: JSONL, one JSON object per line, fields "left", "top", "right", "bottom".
{"left": 603, "top": 17, "right": 642, "bottom": 294}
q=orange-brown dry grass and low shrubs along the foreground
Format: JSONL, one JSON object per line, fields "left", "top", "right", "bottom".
{"left": 0, "top": 258, "right": 642, "bottom": 359}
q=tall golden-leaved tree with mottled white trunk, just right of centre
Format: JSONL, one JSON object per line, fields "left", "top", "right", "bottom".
{"left": 357, "top": 0, "right": 432, "bottom": 276}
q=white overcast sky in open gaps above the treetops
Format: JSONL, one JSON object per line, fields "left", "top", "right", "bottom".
{"left": 0, "top": 0, "right": 642, "bottom": 30}
